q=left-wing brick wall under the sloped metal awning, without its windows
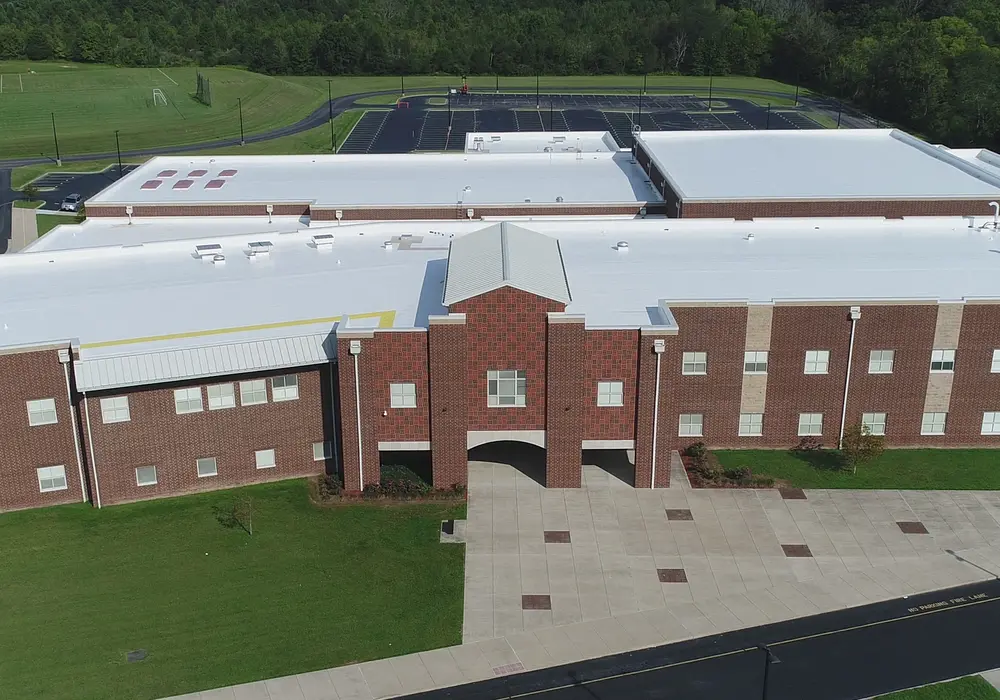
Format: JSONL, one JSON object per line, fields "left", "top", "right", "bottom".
{"left": 84, "top": 368, "right": 331, "bottom": 506}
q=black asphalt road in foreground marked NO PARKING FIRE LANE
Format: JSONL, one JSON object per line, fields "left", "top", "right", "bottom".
{"left": 407, "top": 580, "right": 1000, "bottom": 700}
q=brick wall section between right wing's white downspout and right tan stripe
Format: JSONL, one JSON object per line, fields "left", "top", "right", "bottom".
{"left": 848, "top": 304, "right": 937, "bottom": 445}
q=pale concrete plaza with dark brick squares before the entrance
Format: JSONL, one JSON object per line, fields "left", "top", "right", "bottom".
{"left": 164, "top": 455, "right": 1000, "bottom": 700}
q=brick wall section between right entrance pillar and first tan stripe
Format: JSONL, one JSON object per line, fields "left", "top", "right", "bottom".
{"left": 660, "top": 306, "right": 747, "bottom": 447}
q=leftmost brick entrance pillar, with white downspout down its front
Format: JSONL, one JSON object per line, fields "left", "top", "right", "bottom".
{"left": 337, "top": 324, "right": 380, "bottom": 491}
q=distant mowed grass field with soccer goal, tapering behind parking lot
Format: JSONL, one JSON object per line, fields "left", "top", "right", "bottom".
{"left": 0, "top": 61, "right": 806, "bottom": 160}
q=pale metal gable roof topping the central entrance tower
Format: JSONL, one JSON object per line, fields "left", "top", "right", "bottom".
{"left": 443, "top": 222, "right": 573, "bottom": 306}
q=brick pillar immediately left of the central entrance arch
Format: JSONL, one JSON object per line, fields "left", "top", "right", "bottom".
{"left": 427, "top": 314, "right": 469, "bottom": 488}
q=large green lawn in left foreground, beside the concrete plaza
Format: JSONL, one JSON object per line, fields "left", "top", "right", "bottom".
{"left": 0, "top": 480, "right": 464, "bottom": 700}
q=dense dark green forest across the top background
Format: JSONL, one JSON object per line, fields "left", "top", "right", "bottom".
{"left": 0, "top": 0, "right": 1000, "bottom": 147}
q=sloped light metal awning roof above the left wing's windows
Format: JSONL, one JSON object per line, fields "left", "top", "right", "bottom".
{"left": 74, "top": 333, "right": 337, "bottom": 391}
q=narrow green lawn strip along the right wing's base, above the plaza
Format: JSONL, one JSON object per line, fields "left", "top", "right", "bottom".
{"left": 714, "top": 450, "right": 1000, "bottom": 490}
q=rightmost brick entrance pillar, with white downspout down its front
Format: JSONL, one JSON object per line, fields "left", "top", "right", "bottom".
{"left": 635, "top": 330, "right": 676, "bottom": 488}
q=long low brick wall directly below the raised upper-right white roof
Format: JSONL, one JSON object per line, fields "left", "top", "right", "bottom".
{"left": 681, "top": 199, "right": 993, "bottom": 219}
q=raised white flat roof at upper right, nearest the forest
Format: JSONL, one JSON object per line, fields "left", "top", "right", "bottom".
{"left": 639, "top": 129, "right": 1000, "bottom": 201}
